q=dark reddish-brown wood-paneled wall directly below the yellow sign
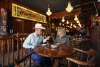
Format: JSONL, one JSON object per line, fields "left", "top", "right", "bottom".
{"left": 13, "top": 18, "right": 36, "bottom": 33}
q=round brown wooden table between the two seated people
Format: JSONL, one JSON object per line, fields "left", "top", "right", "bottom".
{"left": 35, "top": 45, "right": 73, "bottom": 67}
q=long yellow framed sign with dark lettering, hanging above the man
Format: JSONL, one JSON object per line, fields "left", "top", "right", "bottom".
{"left": 12, "top": 3, "right": 46, "bottom": 23}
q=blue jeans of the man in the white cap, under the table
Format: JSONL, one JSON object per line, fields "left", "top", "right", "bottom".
{"left": 28, "top": 49, "right": 52, "bottom": 67}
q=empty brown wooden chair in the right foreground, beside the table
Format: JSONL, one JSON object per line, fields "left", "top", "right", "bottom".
{"left": 66, "top": 48, "right": 96, "bottom": 67}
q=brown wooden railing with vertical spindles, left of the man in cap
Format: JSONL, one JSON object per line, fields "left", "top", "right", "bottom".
{"left": 0, "top": 33, "right": 28, "bottom": 67}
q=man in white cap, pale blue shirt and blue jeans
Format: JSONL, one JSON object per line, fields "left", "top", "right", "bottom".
{"left": 23, "top": 23, "right": 49, "bottom": 65}
